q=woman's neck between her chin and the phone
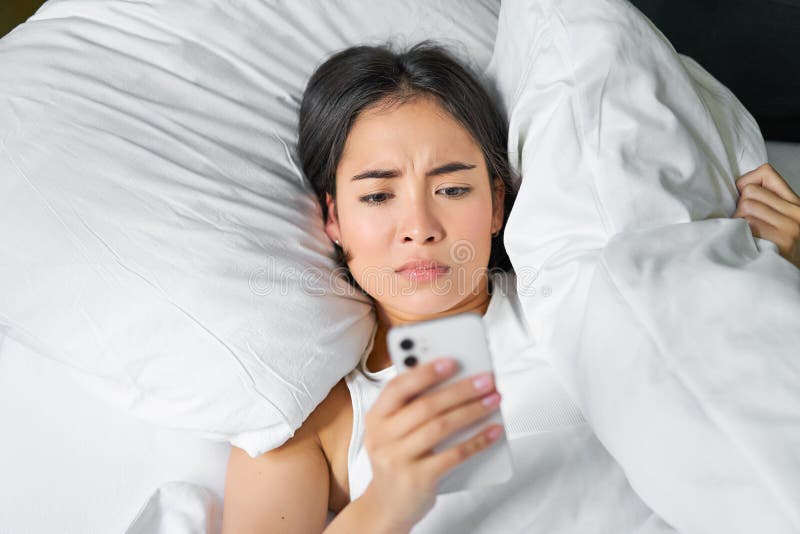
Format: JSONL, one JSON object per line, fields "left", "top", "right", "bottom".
{"left": 367, "top": 276, "right": 491, "bottom": 372}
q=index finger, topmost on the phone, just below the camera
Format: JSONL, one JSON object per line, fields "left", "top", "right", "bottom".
{"left": 367, "top": 358, "right": 456, "bottom": 417}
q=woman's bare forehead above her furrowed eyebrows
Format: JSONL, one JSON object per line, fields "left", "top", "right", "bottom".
{"left": 340, "top": 98, "right": 480, "bottom": 166}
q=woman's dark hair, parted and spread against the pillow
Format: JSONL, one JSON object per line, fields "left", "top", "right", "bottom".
{"left": 297, "top": 41, "right": 516, "bottom": 287}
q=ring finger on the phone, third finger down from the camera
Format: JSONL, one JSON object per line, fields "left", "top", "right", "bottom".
{"left": 399, "top": 391, "right": 500, "bottom": 458}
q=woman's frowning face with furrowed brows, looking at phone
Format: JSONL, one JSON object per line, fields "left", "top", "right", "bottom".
{"left": 325, "top": 98, "right": 504, "bottom": 315}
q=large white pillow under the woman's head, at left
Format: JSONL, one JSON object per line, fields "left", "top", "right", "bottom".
{"left": 0, "top": 0, "right": 499, "bottom": 456}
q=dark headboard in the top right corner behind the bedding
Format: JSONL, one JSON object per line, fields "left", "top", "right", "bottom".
{"left": 631, "top": 0, "right": 800, "bottom": 142}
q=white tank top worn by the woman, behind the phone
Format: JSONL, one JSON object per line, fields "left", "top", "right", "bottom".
{"left": 345, "top": 272, "right": 608, "bottom": 532}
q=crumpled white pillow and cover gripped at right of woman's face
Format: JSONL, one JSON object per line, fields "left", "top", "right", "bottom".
{"left": 487, "top": 0, "right": 800, "bottom": 533}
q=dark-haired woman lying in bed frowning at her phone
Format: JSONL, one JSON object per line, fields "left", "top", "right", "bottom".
{"left": 223, "top": 43, "right": 800, "bottom": 533}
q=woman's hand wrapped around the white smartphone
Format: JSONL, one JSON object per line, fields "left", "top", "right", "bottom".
{"left": 360, "top": 358, "right": 503, "bottom": 530}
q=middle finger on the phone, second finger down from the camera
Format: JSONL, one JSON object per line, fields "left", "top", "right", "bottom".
{"left": 389, "top": 373, "right": 494, "bottom": 444}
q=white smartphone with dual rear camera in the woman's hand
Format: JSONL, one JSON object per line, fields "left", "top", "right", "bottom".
{"left": 386, "top": 312, "right": 513, "bottom": 494}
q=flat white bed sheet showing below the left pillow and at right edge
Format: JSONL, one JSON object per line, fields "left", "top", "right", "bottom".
{"left": 0, "top": 1, "right": 800, "bottom": 534}
